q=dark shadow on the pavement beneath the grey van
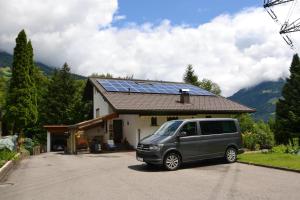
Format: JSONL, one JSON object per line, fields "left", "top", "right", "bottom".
{"left": 128, "top": 158, "right": 227, "bottom": 172}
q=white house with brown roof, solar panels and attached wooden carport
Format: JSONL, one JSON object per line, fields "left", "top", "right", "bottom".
{"left": 45, "top": 78, "right": 255, "bottom": 152}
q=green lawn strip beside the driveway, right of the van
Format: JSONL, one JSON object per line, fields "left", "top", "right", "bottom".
{"left": 238, "top": 153, "right": 300, "bottom": 170}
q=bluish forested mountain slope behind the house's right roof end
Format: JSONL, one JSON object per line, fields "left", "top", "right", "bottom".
{"left": 229, "top": 79, "right": 285, "bottom": 121}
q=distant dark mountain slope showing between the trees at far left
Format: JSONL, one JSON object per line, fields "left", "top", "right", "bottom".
{"left": 0, "top": 51, "right": 85, "bottom": 79}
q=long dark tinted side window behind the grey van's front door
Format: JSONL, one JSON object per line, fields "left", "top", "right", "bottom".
{"left": 200, "top": 121, "right": 237, "bottom": 135}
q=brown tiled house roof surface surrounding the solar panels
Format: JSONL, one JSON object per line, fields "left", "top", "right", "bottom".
{"left": 89, "top": 78, "right": 255, "bottom": 115}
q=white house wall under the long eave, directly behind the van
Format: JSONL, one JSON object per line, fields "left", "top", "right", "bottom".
{"left": 119, "top": 114, "right": 233, "bottom": 147}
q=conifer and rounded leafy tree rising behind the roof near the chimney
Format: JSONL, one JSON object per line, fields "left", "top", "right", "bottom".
{"left": 183, "top": 65, "right": 222, "bottom": 95}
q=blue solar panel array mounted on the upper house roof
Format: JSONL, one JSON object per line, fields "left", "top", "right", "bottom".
{"left": 97, "top": 79, "right": 214, "bottom": 96}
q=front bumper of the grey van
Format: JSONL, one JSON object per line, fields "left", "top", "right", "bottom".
{"left": 136, "top": 150, "right": 163, "bottom": 165}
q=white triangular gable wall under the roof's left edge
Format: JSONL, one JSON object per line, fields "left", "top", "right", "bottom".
{"left": 93, "top": 87, "right": 113, "bottom": 118}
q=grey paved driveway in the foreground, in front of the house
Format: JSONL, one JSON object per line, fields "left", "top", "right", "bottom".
{"left": 0, "top": 152, "right": 300, "bottom": 200}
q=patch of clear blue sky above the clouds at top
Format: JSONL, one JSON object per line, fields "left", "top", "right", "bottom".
{"left": 114, "top": 0, "right": 263, "bottom": 26}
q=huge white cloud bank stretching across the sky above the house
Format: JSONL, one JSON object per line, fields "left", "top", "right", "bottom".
{"left": 0, "top": 0, "right": 300, "bottom": 96}
